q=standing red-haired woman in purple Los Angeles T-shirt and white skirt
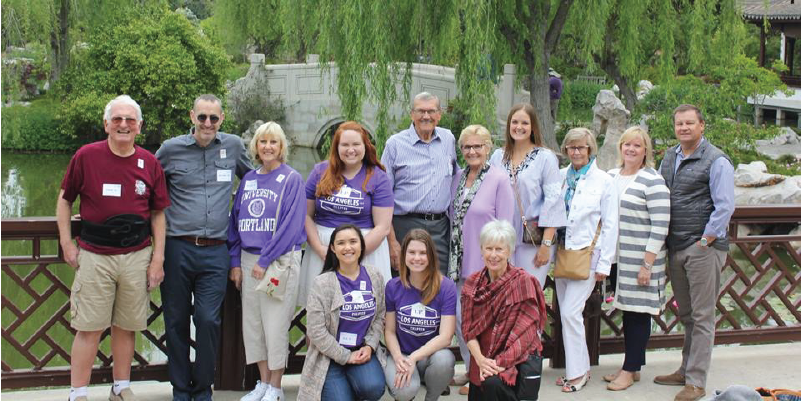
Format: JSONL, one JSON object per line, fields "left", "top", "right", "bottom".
{"left": 298, "top": 121, "right": 394, "bottom": 306}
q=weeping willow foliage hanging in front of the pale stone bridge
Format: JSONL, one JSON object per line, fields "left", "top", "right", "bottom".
{"left": 280, "top": 0, "right": 573, "bottom": 150}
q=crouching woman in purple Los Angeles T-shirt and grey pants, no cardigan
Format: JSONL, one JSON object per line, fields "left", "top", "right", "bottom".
{"left": 384, "top": 228, "right": 456, "bottom": 401}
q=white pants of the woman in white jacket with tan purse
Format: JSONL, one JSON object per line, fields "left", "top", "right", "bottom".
{"left": 556, "top": 248, "right": 600, "bottom": 380}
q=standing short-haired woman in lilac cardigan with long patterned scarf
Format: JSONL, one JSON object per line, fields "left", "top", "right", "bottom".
{"left": 448, "top": 125, "right": 514, "bottom": 395}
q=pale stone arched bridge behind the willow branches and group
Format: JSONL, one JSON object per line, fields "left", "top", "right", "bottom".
{"left": 232, "top": 54, "right": 529, "bottom": 147}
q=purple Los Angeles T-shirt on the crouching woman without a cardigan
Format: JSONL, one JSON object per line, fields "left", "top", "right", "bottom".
{"left": 385, "top": 277, "right": 457, "bottom": 355}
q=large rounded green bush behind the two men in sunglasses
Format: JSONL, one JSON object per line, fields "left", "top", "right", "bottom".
{"left": 59, "top": 7, "right": 229, "bottom": 145}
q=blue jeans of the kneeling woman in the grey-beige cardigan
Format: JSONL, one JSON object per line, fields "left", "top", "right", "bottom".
{"left": 322, "top": 354, "right": 386, "bottom": 401}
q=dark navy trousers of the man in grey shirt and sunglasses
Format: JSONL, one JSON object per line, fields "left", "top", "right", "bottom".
{"left": 161, "top": 237, "right": 231, "bottom": 401}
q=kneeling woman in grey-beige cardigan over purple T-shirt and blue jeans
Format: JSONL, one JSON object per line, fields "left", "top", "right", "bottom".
{"left": 298, "top": 224, "right": 385, "bottom": 401}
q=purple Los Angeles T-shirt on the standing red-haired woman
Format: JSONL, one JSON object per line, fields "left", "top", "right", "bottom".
{"left": 306, "top": 161, "right": 395, "bottom": 228}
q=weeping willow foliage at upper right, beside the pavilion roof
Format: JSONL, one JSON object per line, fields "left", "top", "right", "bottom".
{"left": 565, "top": 0, "right": 745, "bottom": 110}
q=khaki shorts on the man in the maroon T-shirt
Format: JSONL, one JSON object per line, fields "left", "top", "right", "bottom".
{"left": 70, "top": 246, "right": 152, "bottom": 331}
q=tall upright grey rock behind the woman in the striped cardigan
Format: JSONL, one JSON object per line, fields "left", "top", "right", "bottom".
{"left": 592, "top": 89, "right": 631, "bottom": 170}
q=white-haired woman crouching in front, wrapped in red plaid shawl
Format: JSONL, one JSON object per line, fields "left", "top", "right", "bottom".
{"left": 461, "top": 220, "right": 548, "bottom": 401}
